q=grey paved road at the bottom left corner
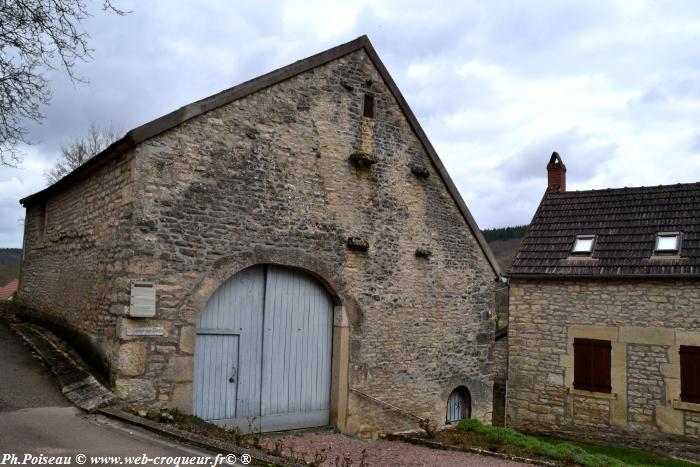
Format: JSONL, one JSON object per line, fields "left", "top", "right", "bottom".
{"left": 0, "top": 317, "right": 227, "bottom": 465}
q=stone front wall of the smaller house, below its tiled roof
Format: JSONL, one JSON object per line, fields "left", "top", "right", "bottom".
{"left": 507, "top": 278, "right": 700, "bottom": 458}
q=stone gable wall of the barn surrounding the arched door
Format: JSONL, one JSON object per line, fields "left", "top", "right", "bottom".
{"left": 71, "top": 47, "right": 495, "bottom": 434}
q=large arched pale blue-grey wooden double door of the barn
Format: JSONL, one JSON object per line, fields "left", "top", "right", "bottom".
{"left": 193, "top": 266, "right": 333, "bottom": 431}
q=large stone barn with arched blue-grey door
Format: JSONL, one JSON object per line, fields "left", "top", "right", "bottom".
{"left": 19, "top": 36, "right": 499, "bottom": 436}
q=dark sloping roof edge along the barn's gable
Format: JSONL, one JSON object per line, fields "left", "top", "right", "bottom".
{"left": 19, "top": 35, "right": 501, "bottom": 276}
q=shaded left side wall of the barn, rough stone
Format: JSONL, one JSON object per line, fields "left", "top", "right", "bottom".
{"left": 18, "top": 154, "right": 133, "bottom": 372}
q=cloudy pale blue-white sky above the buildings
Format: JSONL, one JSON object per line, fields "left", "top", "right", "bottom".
{"left": 0, "top": 0, "right": 700, "bottom": 247}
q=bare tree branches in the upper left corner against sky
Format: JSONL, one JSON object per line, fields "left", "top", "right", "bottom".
{"left": 0, "top": 0, "right": 129, "bottom": 166}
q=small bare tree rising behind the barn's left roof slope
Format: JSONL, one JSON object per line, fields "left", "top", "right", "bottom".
{"left": 44, "top": 123, "right": 121, "bottom": 184}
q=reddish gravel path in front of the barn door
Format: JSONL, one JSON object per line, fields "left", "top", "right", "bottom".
{"left": 261, "top": 433, "right": 530, "bottom": 467}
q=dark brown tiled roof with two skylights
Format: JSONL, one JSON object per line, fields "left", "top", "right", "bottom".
{"left": 509, "top": 183, "right": 700, "bottom": 278}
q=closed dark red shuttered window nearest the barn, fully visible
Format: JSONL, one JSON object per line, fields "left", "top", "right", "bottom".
{"left": 574, "top": 338, "right": 612, "bottom": 393}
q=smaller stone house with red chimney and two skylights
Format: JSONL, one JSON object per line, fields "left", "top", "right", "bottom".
{"left": 507, "top": 153, "right": 700, "bottom": 457}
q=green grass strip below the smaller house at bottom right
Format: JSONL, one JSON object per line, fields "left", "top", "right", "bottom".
{"left": 454, "top": 420, "right": 697, "bottom": 467}
